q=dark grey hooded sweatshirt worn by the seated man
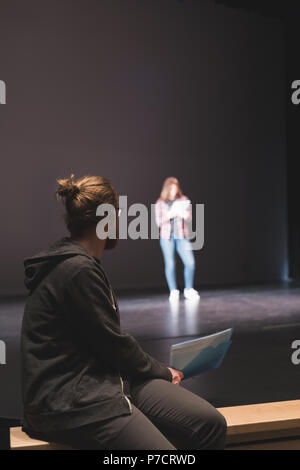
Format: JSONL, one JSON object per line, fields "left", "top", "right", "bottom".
{"left": 22, "top": 238, "right": 172, "bottom": 436}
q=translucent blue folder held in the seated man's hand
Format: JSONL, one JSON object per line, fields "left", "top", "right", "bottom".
{"left": 170, "top": 328, "right": 233, "bottom": 379}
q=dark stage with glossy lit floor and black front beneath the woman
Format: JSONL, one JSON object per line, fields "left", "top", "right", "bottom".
{"left": 0, "top": 284, "right": 300, "bottom": 418}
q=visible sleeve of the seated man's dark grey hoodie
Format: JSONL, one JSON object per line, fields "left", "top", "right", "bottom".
{"left": 65, "top": 267, "right": 172, "bottom": 382}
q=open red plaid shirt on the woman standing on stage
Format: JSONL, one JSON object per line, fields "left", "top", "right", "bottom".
{"left": 155, "top": 196, "right": 192, "bottom": 239}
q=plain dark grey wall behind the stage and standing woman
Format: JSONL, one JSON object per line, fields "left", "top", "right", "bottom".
{"left": 0, "top": 0, "right": 286, "bottom": 293}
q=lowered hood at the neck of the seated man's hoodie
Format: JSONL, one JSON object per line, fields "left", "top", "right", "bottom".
{"left": 24, "top": 237, "right": 94, "bottom": 292}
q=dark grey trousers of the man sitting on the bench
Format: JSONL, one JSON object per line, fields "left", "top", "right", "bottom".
{"left": 48, "top": 379, "right": 226, "bottom": 450}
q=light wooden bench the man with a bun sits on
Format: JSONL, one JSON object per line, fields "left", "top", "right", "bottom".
{"left": 10, "top": 400, "right": 300, "bottom": 450}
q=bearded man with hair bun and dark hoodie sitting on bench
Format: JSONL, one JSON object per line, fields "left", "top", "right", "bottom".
{"left": 21, "top": 175, "right": 226, "bottom": 450}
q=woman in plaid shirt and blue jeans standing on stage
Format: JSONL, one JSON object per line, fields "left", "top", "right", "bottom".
{"left": 155, "top": 177, "right": 199, "bottom": 300}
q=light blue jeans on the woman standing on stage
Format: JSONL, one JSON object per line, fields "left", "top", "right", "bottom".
{"left": 160, "top": 233, "right": 195, "bottom": 290}
